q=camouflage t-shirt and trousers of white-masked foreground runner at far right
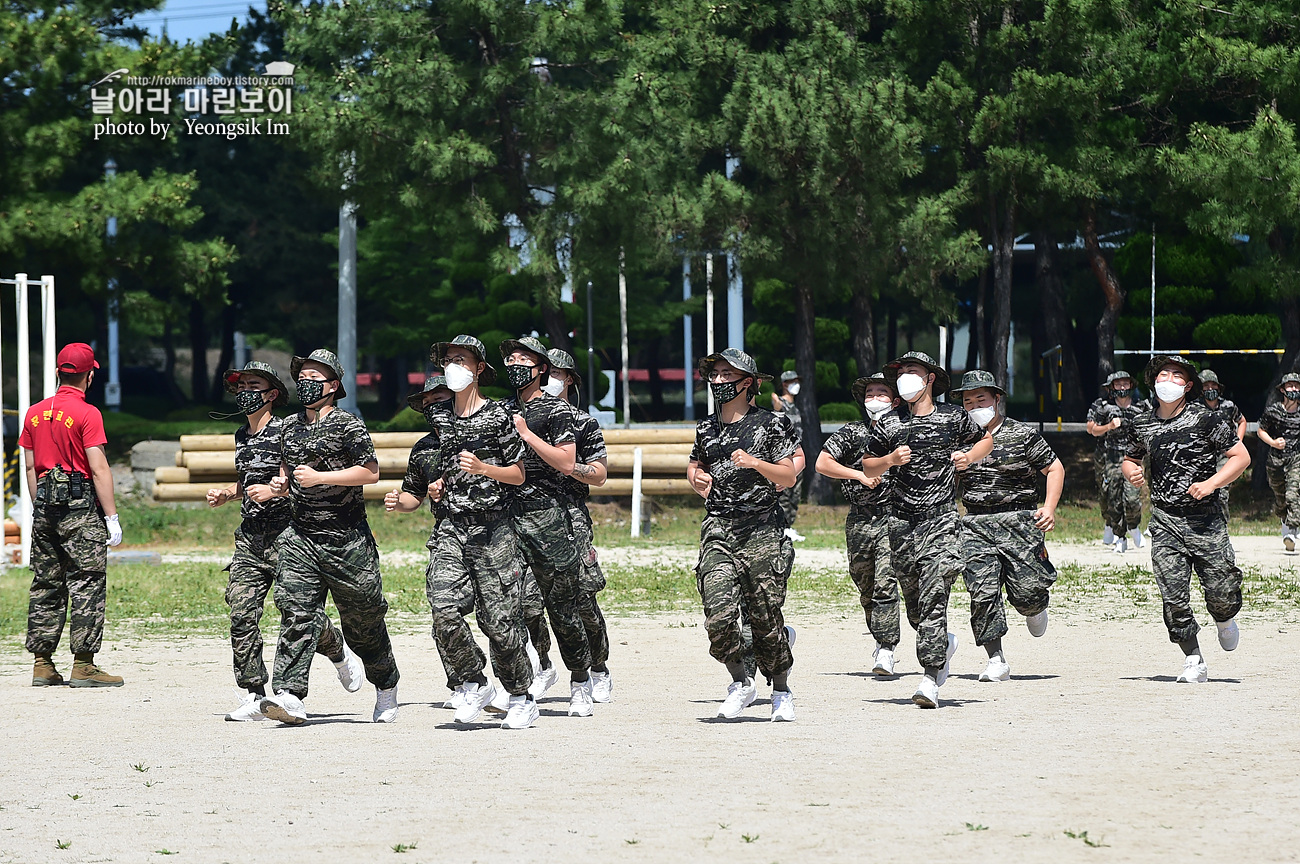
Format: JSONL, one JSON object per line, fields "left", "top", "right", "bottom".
{"left": 1127, "top": 403, "right": 1242, "bottom": 642}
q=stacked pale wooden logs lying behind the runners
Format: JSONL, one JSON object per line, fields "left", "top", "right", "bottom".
{"left": 153, "top": 426, "right": 696, "bottom": 502}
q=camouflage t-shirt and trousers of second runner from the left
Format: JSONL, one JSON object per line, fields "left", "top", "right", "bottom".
{"left": 273, "top": 408, "right": 399, "bottom": 699}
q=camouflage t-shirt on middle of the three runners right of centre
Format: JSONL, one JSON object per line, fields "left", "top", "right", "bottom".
{"left": 867, "top": 401, "right": 985, "bottom": 515}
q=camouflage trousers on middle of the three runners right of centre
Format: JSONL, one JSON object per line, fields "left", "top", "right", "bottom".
{"left": 889, "top": 509, "right": 963, "bottom": 668}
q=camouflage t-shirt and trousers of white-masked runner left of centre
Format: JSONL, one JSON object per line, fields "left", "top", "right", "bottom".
{"left": 425, "top": 401, "right": 533, "bottom": 696}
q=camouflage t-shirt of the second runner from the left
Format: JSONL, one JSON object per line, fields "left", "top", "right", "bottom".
{"left": 281, "top": 408, "right": 376, "bottom": 537}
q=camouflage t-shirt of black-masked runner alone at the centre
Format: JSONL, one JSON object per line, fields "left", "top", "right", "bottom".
{"left": 690, "top": 405, "right": 797, "bottom": 518}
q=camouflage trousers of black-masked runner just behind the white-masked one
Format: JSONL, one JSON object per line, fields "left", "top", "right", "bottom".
{"left": 515, "top": 502, "right": 592, "bottom": 672}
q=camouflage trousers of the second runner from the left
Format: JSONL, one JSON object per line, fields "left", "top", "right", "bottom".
{"left": 272, "top": 522, "right": 400, "bottom": 699}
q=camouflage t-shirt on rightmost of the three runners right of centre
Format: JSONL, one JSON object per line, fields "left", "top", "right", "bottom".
{"left": 957, "top": 417, "right": 1056, "bottom": 509}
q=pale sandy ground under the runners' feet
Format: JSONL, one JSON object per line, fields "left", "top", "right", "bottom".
{"left": 0, "top": 582, "right": 1300, "bottom": 864}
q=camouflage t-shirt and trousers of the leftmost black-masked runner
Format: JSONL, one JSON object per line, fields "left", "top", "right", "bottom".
{"left": 226, "top": 417, "right": 343, "bottom": 690}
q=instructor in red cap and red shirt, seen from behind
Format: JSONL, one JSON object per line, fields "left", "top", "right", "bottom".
{"left": 18, "top": 342, "right": 122, "bottom": 687}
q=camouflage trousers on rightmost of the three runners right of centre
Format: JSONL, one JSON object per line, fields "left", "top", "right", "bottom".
{"left": 962, "top": 511, "right": 1056, "bottom": 644}
